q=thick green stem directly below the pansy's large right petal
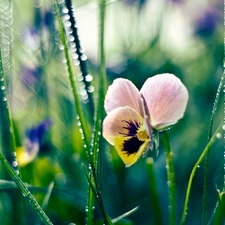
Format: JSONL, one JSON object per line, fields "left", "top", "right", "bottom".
{"left": 162, "top": 131, "right": 176, "bottom": 225}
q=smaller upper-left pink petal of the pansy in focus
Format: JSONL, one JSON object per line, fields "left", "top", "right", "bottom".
{"left": 105, "top": 78, "right": 141, "bottom": 114}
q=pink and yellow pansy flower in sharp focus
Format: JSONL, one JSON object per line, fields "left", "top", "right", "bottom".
{"left": 103, "top": 73, "right": 188, "bottom": 167}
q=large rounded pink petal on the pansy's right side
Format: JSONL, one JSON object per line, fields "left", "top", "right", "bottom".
{"left": 140, "top": 73, "right": 188, "bottom": 130}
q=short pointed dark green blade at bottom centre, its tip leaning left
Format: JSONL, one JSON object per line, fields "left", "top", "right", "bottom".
{"left": 83, "top": 165, "right": 113, "bottom": 225}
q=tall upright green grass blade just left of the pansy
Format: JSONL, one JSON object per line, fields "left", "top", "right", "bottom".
{"left": 87, "top": 0, "right": 106, "bottom": 222}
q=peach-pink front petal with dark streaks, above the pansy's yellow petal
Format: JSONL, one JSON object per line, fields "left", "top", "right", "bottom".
{"left": 103, "top": 106, "right": 144, "bottom": 145}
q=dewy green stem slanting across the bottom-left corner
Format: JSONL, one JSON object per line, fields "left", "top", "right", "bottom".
{"left": 0, "top": 151, "right": 53, "bottom": 225}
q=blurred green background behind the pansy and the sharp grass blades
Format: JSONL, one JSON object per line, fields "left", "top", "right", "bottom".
{"left": 0, "top": 0, "right": 224, "bottom": 225}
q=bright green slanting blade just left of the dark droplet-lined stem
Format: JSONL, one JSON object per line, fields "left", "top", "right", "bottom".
{"left": 54, "top": 2, "right": 90, "bottom": 151}
